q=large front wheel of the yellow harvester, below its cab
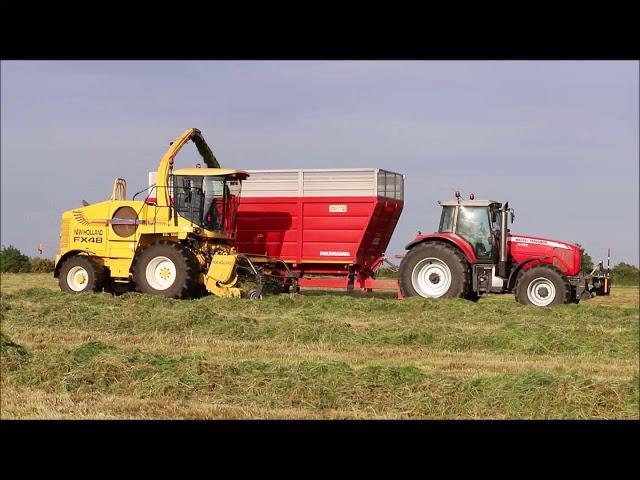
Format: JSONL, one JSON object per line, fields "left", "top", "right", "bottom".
{"left": 133, "top": 240, "right": 199, "bottom": 298}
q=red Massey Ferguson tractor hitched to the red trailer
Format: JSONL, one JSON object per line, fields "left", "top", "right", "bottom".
{"left": 399, "top": 192, "right": 611, "bottom": 307}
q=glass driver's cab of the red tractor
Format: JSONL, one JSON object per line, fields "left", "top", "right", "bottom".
{"left": 438, "top": 200, "right": 502, "bottom": 263}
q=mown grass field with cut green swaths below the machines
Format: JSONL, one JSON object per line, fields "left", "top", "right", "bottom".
{"left": 0, "top": 274, "right": 640, "bottom": 419}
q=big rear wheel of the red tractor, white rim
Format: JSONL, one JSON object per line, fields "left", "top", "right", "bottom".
{"left": 400, "top": 242, "right": 470, "bottom": 298}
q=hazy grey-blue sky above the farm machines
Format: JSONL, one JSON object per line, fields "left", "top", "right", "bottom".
{"left": 0, "top": 61, "right": 639, "bottom": 265}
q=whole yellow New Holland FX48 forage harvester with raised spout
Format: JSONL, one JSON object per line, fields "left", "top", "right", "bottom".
{"left": 54, "top": 128, "right": 296, "bottom": 298}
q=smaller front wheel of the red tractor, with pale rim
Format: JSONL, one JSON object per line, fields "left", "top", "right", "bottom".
{"left": 514, "top": 265, "right": 571, "bottom": 307}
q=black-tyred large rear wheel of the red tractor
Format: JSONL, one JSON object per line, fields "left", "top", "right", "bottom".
{"left": 399, "top": 242, "right": 471, "bottom": 298}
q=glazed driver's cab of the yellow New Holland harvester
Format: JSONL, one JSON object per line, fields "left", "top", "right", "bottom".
{"left": 169, "top": 168, "right": 249, "bottom": 238}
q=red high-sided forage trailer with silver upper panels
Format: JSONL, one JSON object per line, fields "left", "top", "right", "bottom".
{"left": 235, "top": 168, "right": 404, "bottom": 296}
